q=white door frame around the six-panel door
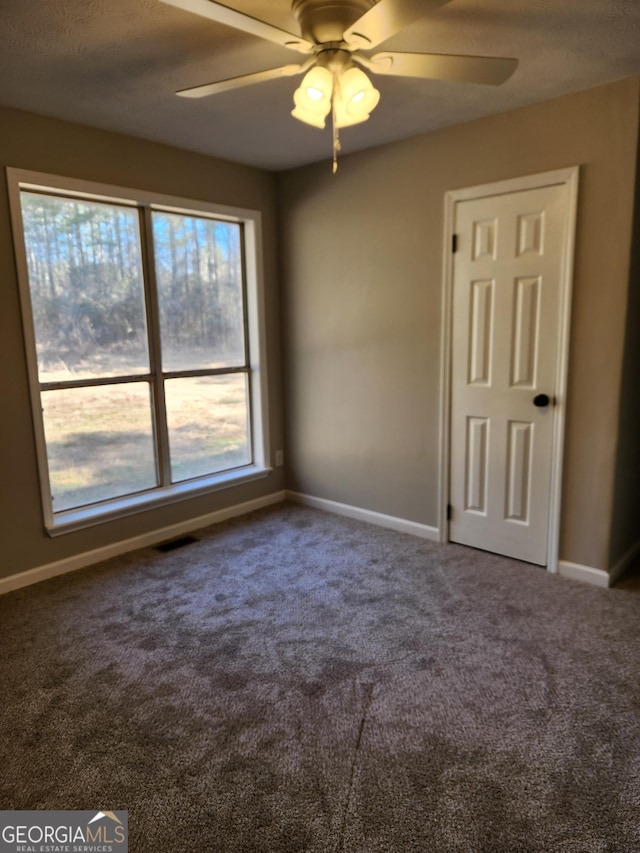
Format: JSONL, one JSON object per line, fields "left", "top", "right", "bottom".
{"left": 438, "top": 166, "right": 580, "bottom": 573}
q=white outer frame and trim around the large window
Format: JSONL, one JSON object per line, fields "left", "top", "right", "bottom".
{"left": 6, "top": 167, "right": 272, "bottom": 536}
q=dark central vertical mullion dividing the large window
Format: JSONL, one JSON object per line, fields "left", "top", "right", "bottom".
{"left": 140, "top": 207, "right": 171, "bottom": 486}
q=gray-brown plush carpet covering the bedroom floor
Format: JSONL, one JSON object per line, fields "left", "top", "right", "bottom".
{"left": 0, "top": 504, "right": 640, "bottom": 853}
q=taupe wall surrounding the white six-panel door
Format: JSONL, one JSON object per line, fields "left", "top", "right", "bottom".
{"left": 279, "top": 78, "right": 640, "bottom": 569}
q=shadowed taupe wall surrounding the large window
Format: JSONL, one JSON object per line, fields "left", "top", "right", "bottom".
{"left": 0, "top": 103, "right": 283, "bottom": 577}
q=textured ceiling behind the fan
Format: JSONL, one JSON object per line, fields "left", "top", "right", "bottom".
{"left": 0, "top": 0, "right": 640, "bottom": 169}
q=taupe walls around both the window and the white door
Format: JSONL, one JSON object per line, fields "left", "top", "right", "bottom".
{"left": 5, "top": 78, "right": 640, "bottom": 577}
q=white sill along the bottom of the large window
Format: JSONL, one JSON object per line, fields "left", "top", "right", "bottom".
{"left": 46, "top": 465, "right": 273, "bottom": 536}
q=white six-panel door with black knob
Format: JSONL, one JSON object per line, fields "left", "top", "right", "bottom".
{"left": 449, "top": 185, "right": 567, "bottom": 565}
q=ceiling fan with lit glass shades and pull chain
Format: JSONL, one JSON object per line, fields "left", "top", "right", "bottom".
{"left": 161, "top": 0, "right": 518, "bottom": 172}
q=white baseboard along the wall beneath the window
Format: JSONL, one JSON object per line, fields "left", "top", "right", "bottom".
{"left": 0, "top": 491, "right": 285, "bottom": 595}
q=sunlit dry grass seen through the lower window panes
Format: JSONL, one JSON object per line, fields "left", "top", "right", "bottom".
{"left": 42, "top": 348, "right": 251, "bottom": 512}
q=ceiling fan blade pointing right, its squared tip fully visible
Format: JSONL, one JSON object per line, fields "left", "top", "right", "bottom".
{"left": 362, "top": 52, "right": 518, "bottom": 86}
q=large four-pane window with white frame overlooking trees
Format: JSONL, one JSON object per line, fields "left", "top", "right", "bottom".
{"left": 8, "top": 169, "right": 267, "bottom": 532}
